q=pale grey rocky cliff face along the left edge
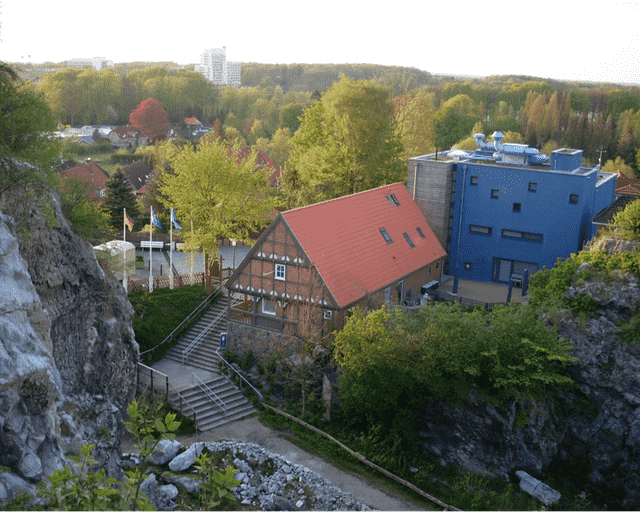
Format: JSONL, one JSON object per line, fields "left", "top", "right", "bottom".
{"left": 0, "top": 162, "right": 139, "bottom": 500}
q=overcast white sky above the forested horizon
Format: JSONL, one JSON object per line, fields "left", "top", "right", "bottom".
{"left": 0, "top": 0, "right": 640, "bottom": 84}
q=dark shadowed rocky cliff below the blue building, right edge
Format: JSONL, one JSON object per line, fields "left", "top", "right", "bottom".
{"left": 419, "top": 263, "right": 640, "bottom": 509}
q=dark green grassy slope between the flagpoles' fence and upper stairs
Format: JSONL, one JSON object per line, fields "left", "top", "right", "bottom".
{"left": 129, "top": 285, "right": 214, "bottom": 364}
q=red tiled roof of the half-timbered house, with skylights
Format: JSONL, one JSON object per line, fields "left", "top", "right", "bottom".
{"left": 282, "top": 183, "right": 446, "bottom": 308}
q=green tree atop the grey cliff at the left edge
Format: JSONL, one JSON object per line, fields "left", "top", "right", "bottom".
{"left": 0, "top": 62, "right": 58, "bottom": 200}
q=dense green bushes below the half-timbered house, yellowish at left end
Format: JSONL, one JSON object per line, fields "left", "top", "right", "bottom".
{"left": 334, "top": 304, "right": 574, "bottom": 421}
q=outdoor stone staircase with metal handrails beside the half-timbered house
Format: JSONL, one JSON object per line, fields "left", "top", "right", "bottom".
{"left": 162, "top": 297, "right": 256, "bottom": 432}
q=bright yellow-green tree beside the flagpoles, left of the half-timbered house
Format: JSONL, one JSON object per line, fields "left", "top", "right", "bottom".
{"left": 160, "top": 137, "right": 272, "bottom": 256}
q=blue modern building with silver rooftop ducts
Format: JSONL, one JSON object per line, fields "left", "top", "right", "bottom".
{"left": 407, "top": 132, "right": 616, "bottom": 283}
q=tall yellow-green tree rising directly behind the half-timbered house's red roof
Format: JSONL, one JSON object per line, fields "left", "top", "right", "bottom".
{"left": 288, "top": 76, "right": 404, "bottom": 204}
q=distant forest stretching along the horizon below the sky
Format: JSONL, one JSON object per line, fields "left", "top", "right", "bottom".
{"left": 16, "top": 59, "right": 640, "bottom": 176}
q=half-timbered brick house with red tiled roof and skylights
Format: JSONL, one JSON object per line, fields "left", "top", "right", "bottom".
{"left": 225, "top": 183, "right": 446, "bottom": 332}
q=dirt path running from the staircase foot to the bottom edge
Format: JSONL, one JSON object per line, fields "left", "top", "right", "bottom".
{"left": 122, "top": 417, "right": 430, "bottom": 511}
